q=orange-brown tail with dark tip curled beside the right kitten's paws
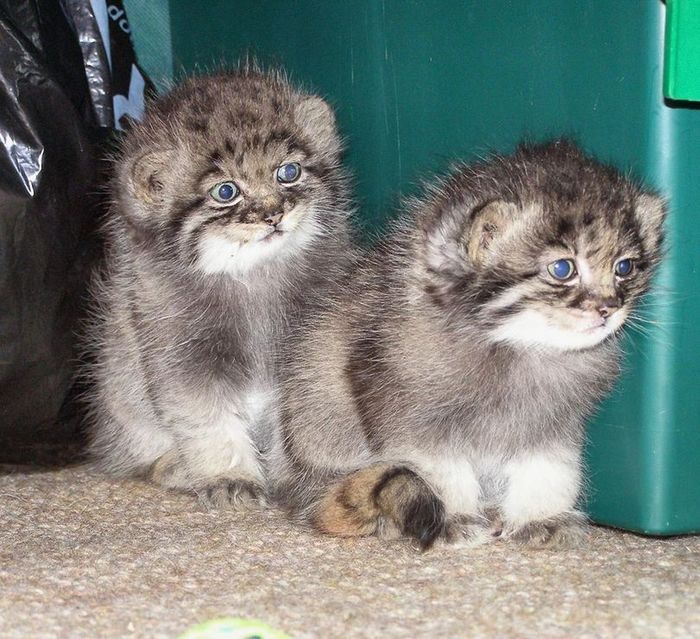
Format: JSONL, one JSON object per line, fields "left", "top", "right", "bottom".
{"left": 311, "top": 464, "right": 446, "bottom": 550}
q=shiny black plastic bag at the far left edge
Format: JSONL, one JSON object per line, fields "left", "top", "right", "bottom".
{"left": 0, "top": 0, "right": 98, "bottom": 450}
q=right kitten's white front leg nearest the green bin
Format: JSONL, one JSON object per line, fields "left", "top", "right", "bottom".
{"left": 501, "top": 448, "right": 586, "bottom": 547}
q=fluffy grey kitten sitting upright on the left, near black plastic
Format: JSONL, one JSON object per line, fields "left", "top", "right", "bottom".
{"left": 89, "top": 69, "right": 350, "bottom": 503}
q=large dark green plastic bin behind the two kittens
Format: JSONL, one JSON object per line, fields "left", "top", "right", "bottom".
{"left": 126, "top": 0, "right": 700, "bottom": 535}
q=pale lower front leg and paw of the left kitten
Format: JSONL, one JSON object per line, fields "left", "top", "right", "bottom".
{"left": 149, "top": 416, "right": 264, "bottom": 508}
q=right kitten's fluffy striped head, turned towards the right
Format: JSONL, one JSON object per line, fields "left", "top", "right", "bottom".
{"left": 421, "top": 141, "right": 666, "bottom": 350}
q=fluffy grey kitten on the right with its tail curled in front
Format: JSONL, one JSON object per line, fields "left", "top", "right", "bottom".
{"left": 275, "top": 141, "right": 665, "bottom": 546}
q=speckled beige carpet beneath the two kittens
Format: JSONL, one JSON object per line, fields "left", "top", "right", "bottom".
{"left": 0, "top": 469, "right": 700, "bottom": 639}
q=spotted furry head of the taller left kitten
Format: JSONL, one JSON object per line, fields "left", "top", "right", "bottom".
{"left": 116, "top": 69, "right": 348, "bottom": 275}
